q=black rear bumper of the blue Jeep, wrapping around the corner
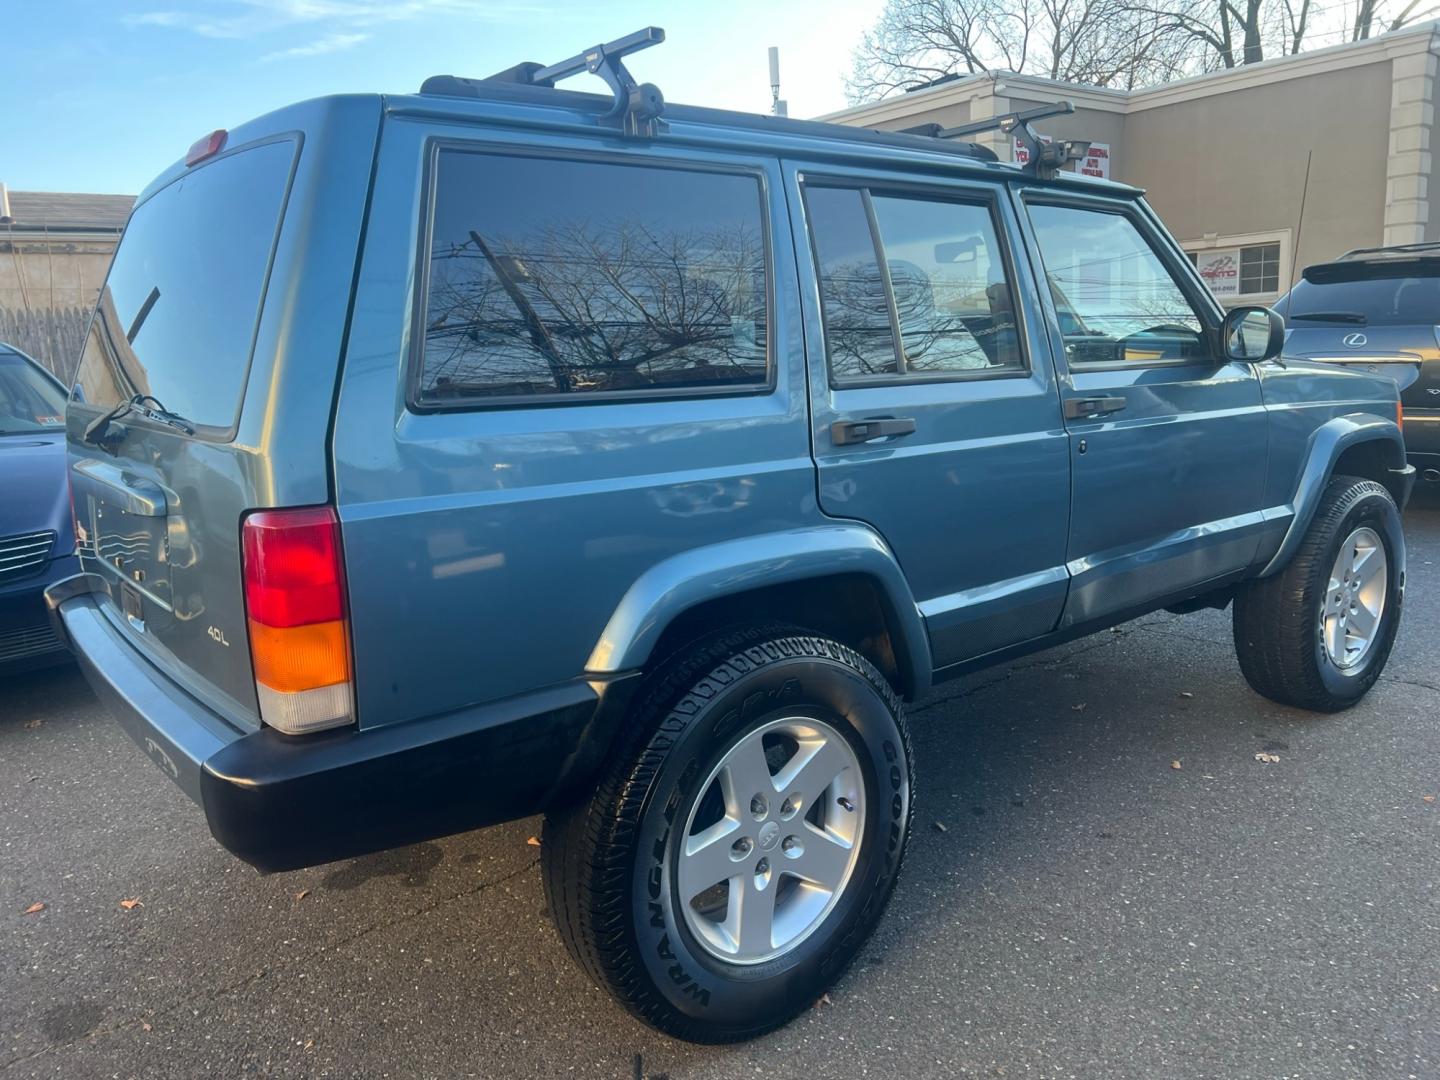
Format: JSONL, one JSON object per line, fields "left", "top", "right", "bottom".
{"left": 46, "top": 577, "right": 634, "bottom": 871}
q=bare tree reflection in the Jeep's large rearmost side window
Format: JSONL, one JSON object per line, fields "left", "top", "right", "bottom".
{"left": 425, "top": 219, "right": 766, "bottom": 396}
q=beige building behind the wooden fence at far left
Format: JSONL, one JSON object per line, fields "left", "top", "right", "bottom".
{"left": 0, "top": 187, "right": 135, "bottom": 382}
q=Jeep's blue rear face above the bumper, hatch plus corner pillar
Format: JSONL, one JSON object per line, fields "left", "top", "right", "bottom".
{"left": 66, "top": 95, "right": 382, "bottom": 730}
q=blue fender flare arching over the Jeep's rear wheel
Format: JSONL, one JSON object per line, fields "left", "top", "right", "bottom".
{"left": 585, "top": 523, "right": 932, "bottom": 696}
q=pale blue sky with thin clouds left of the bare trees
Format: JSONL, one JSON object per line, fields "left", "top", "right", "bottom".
{"left": 0, "top": 0, "right": 881, "bottom": 193}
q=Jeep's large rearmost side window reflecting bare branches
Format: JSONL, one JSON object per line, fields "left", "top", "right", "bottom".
{"left": 413, "top": 148, "right": 769, "bottom": 406}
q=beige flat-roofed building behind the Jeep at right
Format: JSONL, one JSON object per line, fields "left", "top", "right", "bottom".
{"left": 825, "top": 23, "right": 1440, "bottom": 305}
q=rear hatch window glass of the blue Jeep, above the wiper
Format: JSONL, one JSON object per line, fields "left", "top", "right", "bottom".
{"left": 75, "top": 141, "right": 295, "bottom": 431}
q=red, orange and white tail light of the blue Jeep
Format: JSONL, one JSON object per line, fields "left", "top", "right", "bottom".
{"left": 240, "top": 507, "right": 354, "bottom": 734}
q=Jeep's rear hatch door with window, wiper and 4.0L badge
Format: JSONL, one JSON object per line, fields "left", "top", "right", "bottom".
{"left": 69, "top": 140, "right": 298, "bottom": 723}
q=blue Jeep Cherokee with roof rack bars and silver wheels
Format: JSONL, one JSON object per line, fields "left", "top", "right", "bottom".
{"left": 48, "top": 32, "right": 1413, "bottom": 1041}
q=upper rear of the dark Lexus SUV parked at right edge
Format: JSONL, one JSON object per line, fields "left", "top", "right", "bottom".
{"left": 1276, "top": 249, "right": 1440, "bottom": 409}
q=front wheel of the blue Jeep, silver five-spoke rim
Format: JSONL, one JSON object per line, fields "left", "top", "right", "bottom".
{"left": 1234, "top": 477, "right": 1405, "bottom": 713}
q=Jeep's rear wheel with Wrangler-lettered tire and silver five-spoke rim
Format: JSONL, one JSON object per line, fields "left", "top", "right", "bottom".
{"left": 541, "top": 628, "right": 912, "bottom": 1043}
